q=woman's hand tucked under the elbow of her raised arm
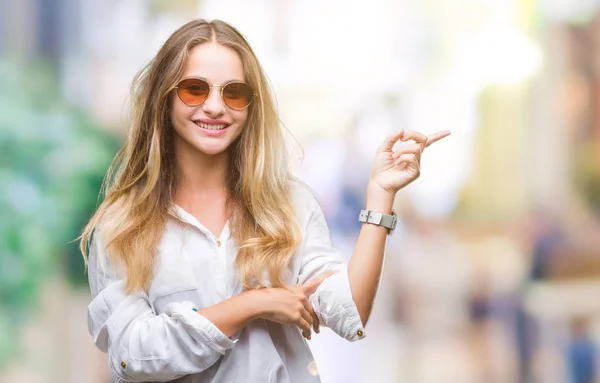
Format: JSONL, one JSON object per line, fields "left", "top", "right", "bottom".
{"left": 257, "top": 272, "right": 334, "bottom": 339}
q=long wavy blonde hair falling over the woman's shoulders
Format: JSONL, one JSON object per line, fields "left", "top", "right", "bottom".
{"left": 80, "top": 20, "right": 301, "bottom": 292}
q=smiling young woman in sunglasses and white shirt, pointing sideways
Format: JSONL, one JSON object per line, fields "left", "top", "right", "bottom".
{"left": 81, "top": 20, "right": 449, "bottom": 382}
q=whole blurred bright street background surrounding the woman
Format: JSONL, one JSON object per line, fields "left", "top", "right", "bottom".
{"left": 0, "top": 0, "right": 600, "bottom": 383}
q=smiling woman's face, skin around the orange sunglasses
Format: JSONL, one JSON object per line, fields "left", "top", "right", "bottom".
{"left": 170, "top": 42, "right": 248, "bottom": 160}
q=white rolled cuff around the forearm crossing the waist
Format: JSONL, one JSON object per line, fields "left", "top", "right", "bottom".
{"left": 165, "top": 301, "right": 237, "bottom": 354}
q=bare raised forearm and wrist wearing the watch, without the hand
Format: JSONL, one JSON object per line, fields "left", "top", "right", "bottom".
{"left": 348, "top": 185, "right": 394, "bottom": 325}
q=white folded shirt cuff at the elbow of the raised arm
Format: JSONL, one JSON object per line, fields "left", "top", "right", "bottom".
{"left": 309, "top": 269, "right": 366, "bottom": 342}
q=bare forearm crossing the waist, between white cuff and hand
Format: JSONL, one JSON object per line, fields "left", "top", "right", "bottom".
{"left": 198, "top": 290, "right": 261, "bottom": 337}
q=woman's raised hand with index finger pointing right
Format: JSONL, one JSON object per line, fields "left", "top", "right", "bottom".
{"left": 370, "top": 130, "right": 450, "bottom": 195}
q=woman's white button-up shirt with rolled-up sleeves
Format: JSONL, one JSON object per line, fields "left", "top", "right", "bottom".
{"left": 88, "top": 183, "right": 364, "bottom": 383}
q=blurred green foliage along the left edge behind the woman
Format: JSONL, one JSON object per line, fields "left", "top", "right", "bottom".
{"left": 0, "top": 58, "right": 118, "bottom": 368}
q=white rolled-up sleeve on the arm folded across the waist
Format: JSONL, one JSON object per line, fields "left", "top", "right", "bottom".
{"left": 88, "top": 239, "right": 235, "bottom": 382}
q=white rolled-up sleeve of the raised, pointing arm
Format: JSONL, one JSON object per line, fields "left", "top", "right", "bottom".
{"left": 298, "top": 200, "right": 365, "bottom": 341}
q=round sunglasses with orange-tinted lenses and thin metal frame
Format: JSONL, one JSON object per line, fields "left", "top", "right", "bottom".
{"left": 174, "top": 78, "right": 255, "bottom": 110}
